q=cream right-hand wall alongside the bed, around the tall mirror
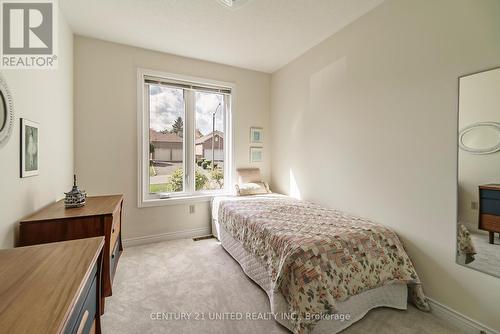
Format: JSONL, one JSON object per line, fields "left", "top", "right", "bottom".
{"left": 271, "top": 0, "right": 500, "bottom": 330}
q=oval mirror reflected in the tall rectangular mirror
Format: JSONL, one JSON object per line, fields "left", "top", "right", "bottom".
{"left": 458, "top": 122, "right": 500, "bottom": 154}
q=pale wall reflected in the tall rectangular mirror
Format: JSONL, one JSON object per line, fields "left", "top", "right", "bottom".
{"left": 458, "top": 69, "right": 500, "bottom": 231}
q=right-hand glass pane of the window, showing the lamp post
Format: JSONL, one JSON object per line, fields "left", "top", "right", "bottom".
{"left": 195, "top": 92, "right": 225, "bottom": 190}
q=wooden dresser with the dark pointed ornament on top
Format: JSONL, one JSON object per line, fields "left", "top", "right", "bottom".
{"left": 19, "top": 195, "right": 123, "bottom": 312}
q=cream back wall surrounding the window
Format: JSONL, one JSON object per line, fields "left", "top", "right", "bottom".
{"left": 74, "top": 36, "right": 271, "bottom": 239}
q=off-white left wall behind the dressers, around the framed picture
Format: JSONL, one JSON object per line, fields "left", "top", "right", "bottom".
{"left": 0, "top": 9, "right": 73, "bottom": 248}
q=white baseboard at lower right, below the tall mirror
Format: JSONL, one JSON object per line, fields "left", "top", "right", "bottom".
{"left": 427, "top": 297, "right": 499, "bottom": 334}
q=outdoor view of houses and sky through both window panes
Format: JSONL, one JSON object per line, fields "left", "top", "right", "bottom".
{"left": 148, "top": 84, "right": 225, "bottom": 193}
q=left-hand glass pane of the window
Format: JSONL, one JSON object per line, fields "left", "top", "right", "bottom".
{"left": 149, "top": 85, "right": 185, "bottom": 193}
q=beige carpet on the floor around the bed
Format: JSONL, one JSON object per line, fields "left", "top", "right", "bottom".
{"left": 102, "top": 239, "right": 460, "bottom": 334}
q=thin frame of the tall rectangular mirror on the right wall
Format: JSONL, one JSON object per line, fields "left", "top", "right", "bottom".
{"left": 455, "top": 66, "right": 500, "bottom": 278}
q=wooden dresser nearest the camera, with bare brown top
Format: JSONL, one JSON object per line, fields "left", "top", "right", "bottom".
{"left": 0, "top": 237, "right": 104, "bottom": 334}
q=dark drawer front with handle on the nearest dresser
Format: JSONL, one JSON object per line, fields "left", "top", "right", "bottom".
{"left": 64, "top": 266, "right": 98, "bottom": 334}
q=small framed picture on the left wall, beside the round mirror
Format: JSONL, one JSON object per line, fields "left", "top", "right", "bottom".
{"left": 21, "top": 118, "right": 40, "bottom": 177}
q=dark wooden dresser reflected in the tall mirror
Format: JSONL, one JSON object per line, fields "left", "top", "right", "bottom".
{"left": 479, "top": 184, "right": 500, "bottom": 244}
